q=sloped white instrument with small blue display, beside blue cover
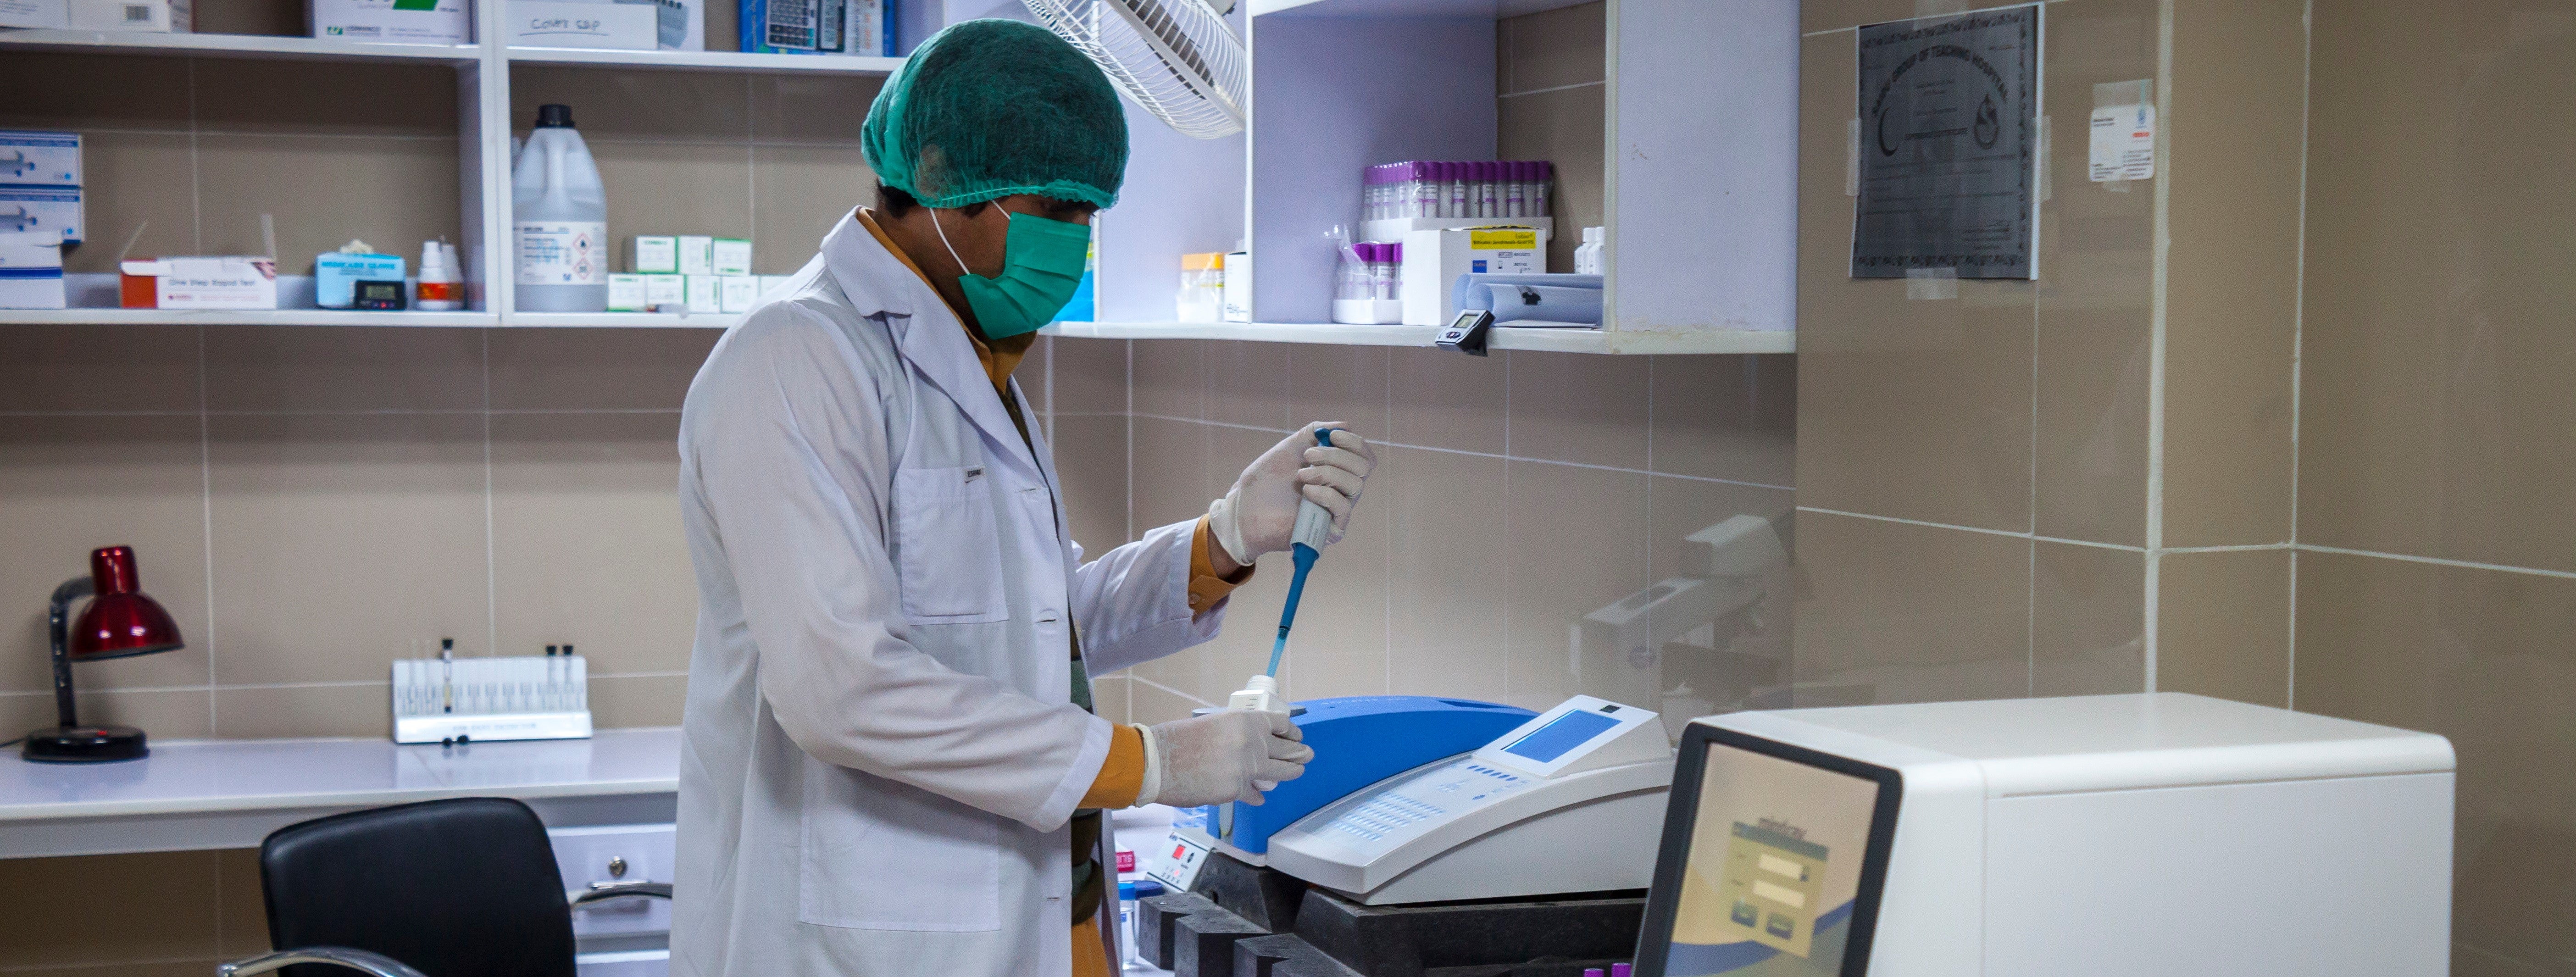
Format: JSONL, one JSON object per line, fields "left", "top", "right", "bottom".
{"left": 1270, "top": 696, "right": 1672, "bottom": 905}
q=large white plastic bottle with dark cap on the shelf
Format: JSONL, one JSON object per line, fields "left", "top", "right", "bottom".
{"left": 510, "top": 105, "right": 608, "bottom": 312}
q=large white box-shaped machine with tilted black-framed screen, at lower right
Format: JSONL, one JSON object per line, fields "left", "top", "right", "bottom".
{"left": 1636, "top": 694, "right": 2452, "bottom": 977}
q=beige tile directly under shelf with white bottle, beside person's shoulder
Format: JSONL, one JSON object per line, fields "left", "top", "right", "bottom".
{"left": 487, "top": 330, "right": 724, "bottom": 410}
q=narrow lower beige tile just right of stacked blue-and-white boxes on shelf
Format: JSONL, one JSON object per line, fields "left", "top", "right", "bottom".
{"left": 62, "top": 132, "right": 201, "bottom": 276}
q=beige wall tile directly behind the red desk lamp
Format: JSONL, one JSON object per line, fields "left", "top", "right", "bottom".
{"left": 0, "top": 415, "right": 214, "bottom": 696}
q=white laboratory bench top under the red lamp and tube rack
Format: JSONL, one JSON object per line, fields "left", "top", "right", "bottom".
{"left": 0, "top": 729, "right": 680, "bottom": 858}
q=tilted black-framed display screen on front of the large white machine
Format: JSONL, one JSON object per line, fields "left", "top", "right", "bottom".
{"left": 1636, "top": 724, "right": 1901, "bottom": 977}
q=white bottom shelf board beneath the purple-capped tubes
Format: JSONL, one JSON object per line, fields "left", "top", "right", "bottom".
{"left": 1046, "top": 322, "right": 1798, "bottom": 356}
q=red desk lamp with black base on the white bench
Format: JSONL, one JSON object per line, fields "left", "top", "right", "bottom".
{"left": 23, "top": 546, "right": 185, "bottom": 763}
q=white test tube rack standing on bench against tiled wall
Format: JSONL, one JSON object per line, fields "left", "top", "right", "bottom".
{"left": 394, "top": 655, "right": 590, "bottom": 743}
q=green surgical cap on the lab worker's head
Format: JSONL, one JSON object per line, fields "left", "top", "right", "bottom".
{"left": 861, "top": 21, "right": 1126, "bottom": 206}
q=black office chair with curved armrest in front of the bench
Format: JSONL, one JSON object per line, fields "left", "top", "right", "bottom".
{"left": 217, "top": 797, "right": 670, "bottom": 977}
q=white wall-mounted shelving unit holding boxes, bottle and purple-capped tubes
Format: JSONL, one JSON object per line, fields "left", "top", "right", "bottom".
{"left": 0, "top": 0, "right": 1798, "bottom": 353}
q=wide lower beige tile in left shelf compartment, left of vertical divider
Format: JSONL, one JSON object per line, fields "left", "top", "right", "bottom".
{"left": 196, "top": 134, "right": 461, "bottom": 276}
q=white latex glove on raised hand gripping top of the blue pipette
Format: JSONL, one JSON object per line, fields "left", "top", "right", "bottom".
{"left": 1208, "top": 420, "right": 1378, "bottom": 567}
